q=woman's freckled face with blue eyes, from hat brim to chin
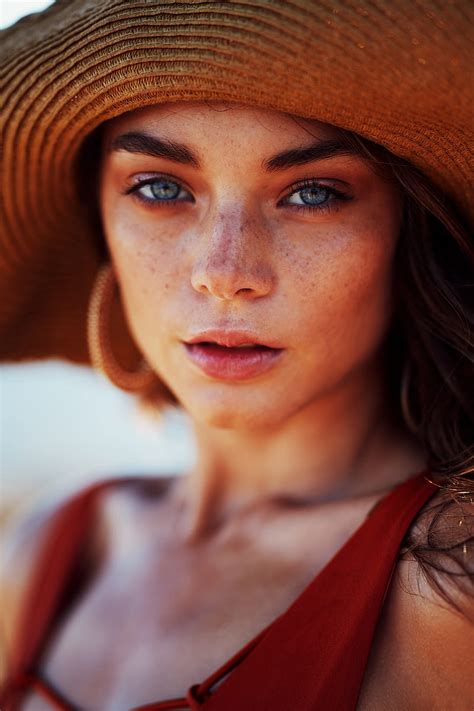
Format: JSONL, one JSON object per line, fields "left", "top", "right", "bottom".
{"left": 100, "top": 102, "right": 401, "bottom": 428}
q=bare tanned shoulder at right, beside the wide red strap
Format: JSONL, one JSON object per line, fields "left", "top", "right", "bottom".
{"left": 358, "top": 494, "right": 474, "bottom": 711}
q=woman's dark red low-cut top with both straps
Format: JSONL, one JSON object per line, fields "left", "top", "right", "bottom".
{"left": 1, "top": 472, "right": 438, "bottom": 711}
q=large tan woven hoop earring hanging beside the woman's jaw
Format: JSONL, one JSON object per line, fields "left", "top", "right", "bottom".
{"left": 87, "top": 263, "right": 157, "bottom": 393}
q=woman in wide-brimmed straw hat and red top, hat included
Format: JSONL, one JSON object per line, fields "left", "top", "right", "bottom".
{"left": 3, "top": 1, "right": 474, "bottom": 711}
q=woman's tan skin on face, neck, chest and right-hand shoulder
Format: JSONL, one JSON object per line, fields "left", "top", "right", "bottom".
{"left": 4, "top": 102, "right": 470, "bottom": 711}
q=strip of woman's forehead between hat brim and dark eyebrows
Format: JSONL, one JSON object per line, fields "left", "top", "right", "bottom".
{"left": 105, "top": 100, "right": 340, "bottom": 140}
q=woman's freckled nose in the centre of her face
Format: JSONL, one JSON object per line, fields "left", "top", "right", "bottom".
{"left": 191, "top": 211, "right": 274, "bottom": 300}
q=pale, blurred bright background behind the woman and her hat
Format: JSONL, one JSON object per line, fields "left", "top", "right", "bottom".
{"left": 0, "top": 0, "right": 194, "bottom": 534}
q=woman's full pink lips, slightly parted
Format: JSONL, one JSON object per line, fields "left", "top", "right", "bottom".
{"left": 183, "top": 330, "right": 284, "bottom": 381}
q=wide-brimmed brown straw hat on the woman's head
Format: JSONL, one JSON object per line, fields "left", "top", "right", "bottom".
{"left": 0, "top": 0, "right": 474, "bottom": 372}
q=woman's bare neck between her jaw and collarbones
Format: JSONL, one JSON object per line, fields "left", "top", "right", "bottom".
{"left": 171, "top": 358, "right": 425, "bottom": 541}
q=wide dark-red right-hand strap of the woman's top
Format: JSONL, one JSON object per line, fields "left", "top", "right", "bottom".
{"left": 198, "top": 472, "right": 438, "bottom": 711}
